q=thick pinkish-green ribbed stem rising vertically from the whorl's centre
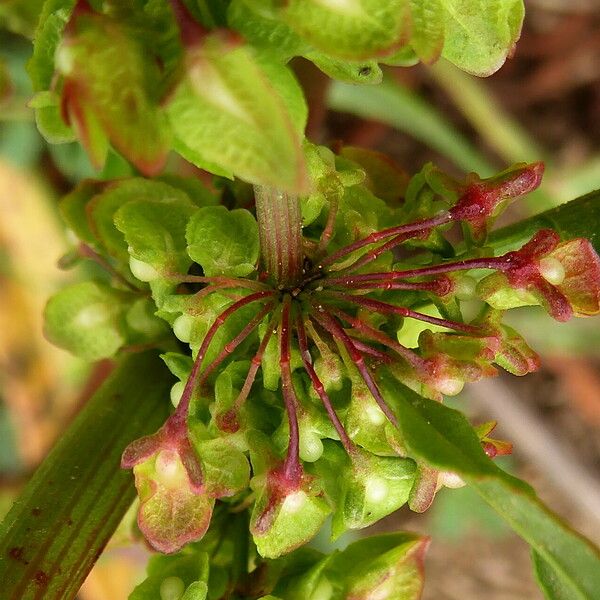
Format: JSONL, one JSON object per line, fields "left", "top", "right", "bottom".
{"left": 254, "top": 185, "right": 304, "bottom": 289}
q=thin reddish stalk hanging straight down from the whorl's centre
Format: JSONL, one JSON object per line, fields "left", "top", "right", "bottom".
{"left": 279, "top": 295, "right": 302, "bottom": 484}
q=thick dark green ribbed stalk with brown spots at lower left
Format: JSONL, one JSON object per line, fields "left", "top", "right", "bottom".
{"left": 0, "top": 353, "right": 170, "bottom": 600}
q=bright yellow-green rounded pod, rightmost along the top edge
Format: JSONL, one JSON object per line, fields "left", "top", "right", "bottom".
{"left": 442, "top": 0, "right": 525, "bottom": 76}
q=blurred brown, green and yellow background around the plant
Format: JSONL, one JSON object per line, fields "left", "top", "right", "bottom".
{"left": 0, "top": 0, "right": 600, "bottom": 600}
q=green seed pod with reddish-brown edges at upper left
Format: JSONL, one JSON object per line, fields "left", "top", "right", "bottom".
{"left": 56, "top": 11, "right": 169, "bottom": 175}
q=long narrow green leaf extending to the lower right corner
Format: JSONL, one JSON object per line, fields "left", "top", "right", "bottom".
{"left": 386, "top": 372, "right": 600, "bottom": 600}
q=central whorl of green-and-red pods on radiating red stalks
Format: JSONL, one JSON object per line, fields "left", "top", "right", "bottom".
{"left": 106, "top": 156, "right": 600, "bottom": 557}
